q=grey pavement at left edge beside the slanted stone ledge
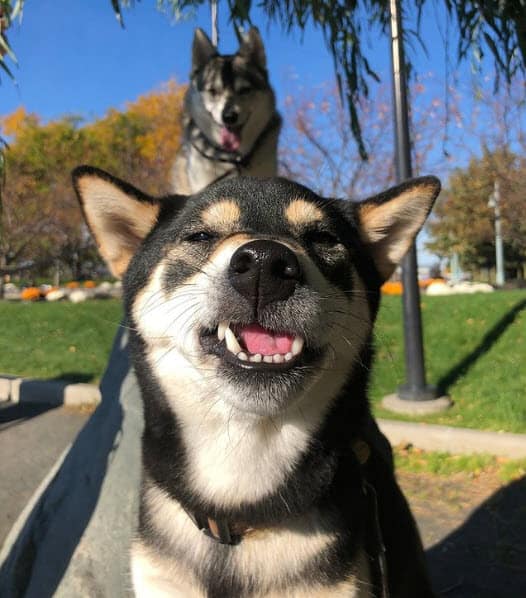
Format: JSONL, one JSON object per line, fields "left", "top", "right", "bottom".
{"left": 0, "top": 402, "right": 89, "bottom": 546}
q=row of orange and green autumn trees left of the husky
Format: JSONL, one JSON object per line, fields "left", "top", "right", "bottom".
{"left": 0, "top": 81, "right": 185, "bottom": 292}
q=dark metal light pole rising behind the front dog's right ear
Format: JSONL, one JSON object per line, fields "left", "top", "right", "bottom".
{"left": 390, "top": 0, "right": 436, "bottom": 401}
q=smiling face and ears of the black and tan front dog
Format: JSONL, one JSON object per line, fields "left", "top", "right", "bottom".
{"left": 75, "top": 168, "right": 439, "bottom": 417}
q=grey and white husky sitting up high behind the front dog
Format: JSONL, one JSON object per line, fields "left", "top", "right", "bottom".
{"left": 173, "top": 27, "right": 281, "bottom": 193}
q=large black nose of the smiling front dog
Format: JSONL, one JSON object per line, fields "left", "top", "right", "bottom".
{"left": 228, "top": 240, "right": 302, "bottom": 309}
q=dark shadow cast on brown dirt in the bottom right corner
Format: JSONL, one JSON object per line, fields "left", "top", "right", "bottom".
{"left": 427, "top": 477, "right": 526, "bottom": 598}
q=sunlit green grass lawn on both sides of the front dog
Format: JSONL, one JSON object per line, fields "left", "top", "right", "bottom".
{"left": 0, "top": 291, "right": 526, "bottom": 432}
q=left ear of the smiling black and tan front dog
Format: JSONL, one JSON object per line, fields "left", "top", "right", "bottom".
{"left": 72, "top": 166, "right": 160, "bottom": 278}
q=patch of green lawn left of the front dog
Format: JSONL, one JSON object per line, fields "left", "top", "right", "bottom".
{"left": 0, "top": 300, "right": 122, "bottom": 382}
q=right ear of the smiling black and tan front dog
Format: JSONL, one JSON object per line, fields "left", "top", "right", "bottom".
{"left": 356, "top": 176, "right": 440, "bottom": 280}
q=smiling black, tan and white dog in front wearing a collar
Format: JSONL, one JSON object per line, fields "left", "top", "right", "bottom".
{"left": 74, "top": 167, "right": 440, "bottom": 598}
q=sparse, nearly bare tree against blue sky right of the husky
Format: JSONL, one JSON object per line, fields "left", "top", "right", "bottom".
{"left": 280, "top": 75, "right": 456, "bottom": 198}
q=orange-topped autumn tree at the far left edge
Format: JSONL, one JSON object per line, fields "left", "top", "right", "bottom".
{"left": 0, "top": 109, "right": 93, "bottom": 288}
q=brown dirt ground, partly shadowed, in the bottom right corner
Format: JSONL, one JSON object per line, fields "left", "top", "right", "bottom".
{"left": 398, "top": 471, "right": 526, "bottom": 598}
